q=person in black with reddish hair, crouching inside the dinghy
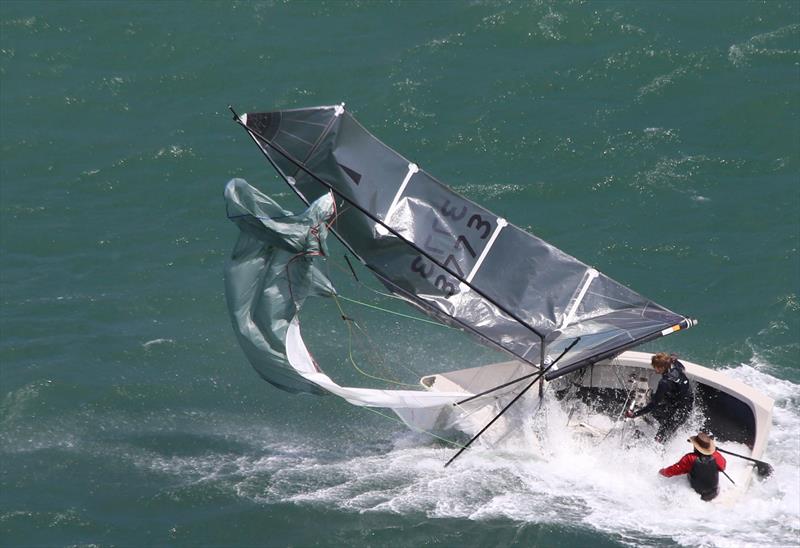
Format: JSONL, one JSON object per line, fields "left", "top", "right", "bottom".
{"left": 625, "top": 352, "right": 694, "bottom": 443}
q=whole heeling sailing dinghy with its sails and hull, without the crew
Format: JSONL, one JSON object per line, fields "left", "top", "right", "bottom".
{"left": 225, "top": 100, "right": 772, "bottom": 498}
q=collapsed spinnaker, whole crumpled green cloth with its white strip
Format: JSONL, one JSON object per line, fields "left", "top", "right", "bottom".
{"left": 225, "top": 179, "right": 470, "bottom": 425}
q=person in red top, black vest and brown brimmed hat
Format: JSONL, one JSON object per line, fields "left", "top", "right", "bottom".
{"left": 658, "top": 432, "right": 726, "bottom": 501}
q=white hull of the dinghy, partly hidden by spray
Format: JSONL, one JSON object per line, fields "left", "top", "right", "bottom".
{"left": 416, "top": 351, "right": 773, "bottom": 503}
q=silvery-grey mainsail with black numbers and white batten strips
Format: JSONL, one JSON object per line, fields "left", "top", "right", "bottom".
{"left": 233, "top": 105, "right": 692, "bottom": 379}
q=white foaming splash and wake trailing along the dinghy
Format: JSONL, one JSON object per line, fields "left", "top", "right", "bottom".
{"left": 138, "top": 364, "right": 800, "bottom": 547}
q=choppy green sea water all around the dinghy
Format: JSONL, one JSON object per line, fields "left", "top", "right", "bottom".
{"left": 0, "top": 0, "right": 800, "bottom": 547}
